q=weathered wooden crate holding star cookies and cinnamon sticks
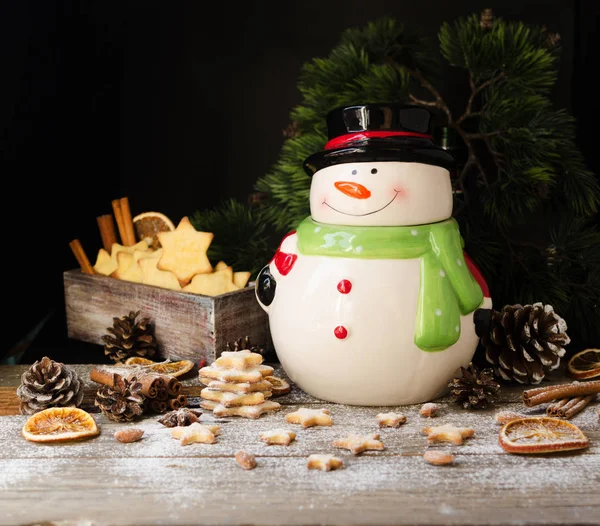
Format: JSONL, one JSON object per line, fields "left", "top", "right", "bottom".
{"left": 63, "top": 269, "right": 273, "bottom": 364}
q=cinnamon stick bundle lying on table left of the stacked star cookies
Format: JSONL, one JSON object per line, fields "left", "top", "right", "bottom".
{"left": 90, "top": 366, "right": 187, "bottom": 413}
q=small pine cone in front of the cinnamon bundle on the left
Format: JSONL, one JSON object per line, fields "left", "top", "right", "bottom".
{"left": 94, "top": 373, "right": 145, "bottom": 422}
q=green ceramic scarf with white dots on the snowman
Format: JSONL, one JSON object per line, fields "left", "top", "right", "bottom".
{"left": 296, "top": 217, "right": 483, "bottom": 351}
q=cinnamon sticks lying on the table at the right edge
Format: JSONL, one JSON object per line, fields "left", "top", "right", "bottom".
{"left": 523, "top": 380, "right": 600, "bottom": 420}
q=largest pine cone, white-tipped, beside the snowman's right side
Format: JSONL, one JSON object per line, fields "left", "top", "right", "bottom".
{"left": 481, "top": 303, "right": 571, "bottom": 384}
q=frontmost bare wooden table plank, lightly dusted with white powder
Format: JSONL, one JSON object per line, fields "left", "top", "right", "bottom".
{"left": 0, "top": 456, "right": 600, "bottom": 526}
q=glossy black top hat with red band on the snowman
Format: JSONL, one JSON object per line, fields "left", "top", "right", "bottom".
{"left": 304, "top": 104, "right": 454, "bottom": 175}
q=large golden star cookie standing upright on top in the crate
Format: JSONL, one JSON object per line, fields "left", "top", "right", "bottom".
{"left": 157, "top": 217, "right": 214, "bottom": 287}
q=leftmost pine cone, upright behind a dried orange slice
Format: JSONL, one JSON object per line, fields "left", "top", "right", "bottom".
{"left": 17, "top": 356, "right": 83, "bottom": 415}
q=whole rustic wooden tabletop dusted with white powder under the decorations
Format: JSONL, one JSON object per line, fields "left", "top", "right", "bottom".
{"left": 0, "top": 365, "right": 600, "bottom": 526}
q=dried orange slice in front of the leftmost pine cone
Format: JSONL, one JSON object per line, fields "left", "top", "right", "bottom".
{"left": 22, "top": 407, "right": 100, "bottom": 442}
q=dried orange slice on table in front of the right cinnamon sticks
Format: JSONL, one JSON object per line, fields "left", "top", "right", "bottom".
{"left": 498, "top": 416, "right": 590, "bottom": 454}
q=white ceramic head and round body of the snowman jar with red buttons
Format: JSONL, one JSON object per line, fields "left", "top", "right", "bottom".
{"left": 263, "top": 162, "right": 491, "bottom": 406}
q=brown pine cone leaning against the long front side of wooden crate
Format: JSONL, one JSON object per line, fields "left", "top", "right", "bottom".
{"left": 102, "top": 311, "right": 157, "bottom": 362}
